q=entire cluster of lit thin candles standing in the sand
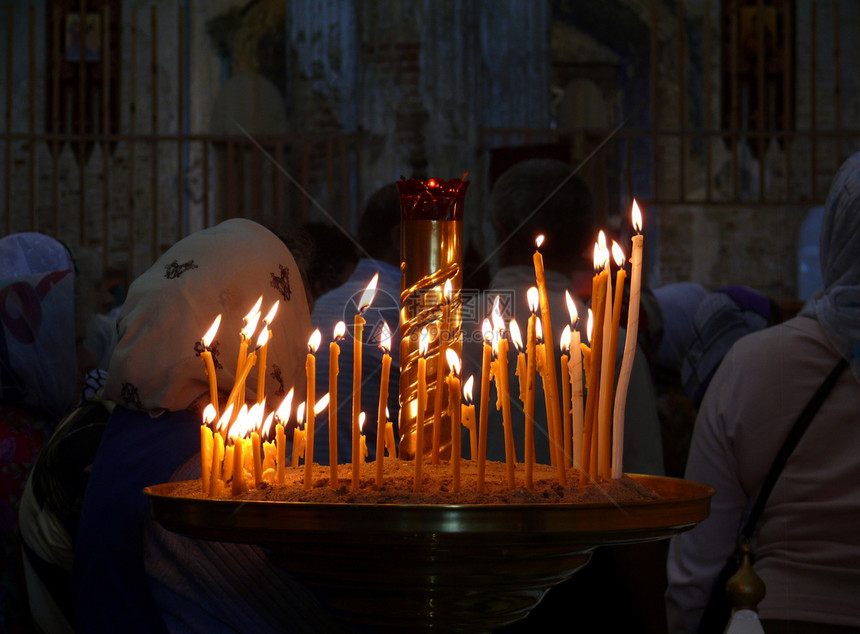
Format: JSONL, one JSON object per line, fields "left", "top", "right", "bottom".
{"left": 200, "top": 201, "right": 643, "bottom": 496}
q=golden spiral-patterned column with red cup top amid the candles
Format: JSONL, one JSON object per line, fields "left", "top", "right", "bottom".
{"left": 397, "top": 179, "right": 469, "bottom": 458}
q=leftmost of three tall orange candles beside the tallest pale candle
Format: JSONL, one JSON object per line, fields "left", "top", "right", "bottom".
{"left": 580, "top": 239, "right": 608, "bottom": 484}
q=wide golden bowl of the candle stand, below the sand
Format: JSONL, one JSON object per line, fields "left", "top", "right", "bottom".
{"left": 144, "top": 475, "right": 714, "bottom": 632}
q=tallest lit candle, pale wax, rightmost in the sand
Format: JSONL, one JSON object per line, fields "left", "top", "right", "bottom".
{"left": 612, "top": 200, "right": 643, "bottom": 478}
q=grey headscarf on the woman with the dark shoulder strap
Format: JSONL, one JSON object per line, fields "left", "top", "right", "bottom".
{"left": 803, "top": 152, "right": 860, "bottom": 379}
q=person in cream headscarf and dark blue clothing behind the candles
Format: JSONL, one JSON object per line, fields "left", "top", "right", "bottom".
{"left": 73, "top": 219, "right": 342, "bottom": 632}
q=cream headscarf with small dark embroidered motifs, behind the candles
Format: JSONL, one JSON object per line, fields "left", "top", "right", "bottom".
{"left": 105, "top": 218, "right": 311, "bottom": 414}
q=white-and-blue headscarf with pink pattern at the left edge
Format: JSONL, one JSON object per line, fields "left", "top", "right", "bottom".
{"left": 0, "top": 233, "right": 77, "bottom": 419}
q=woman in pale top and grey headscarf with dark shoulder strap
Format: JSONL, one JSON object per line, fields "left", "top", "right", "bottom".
{"left": 666, "top": 153, "right": 860, "bottom": 632}
